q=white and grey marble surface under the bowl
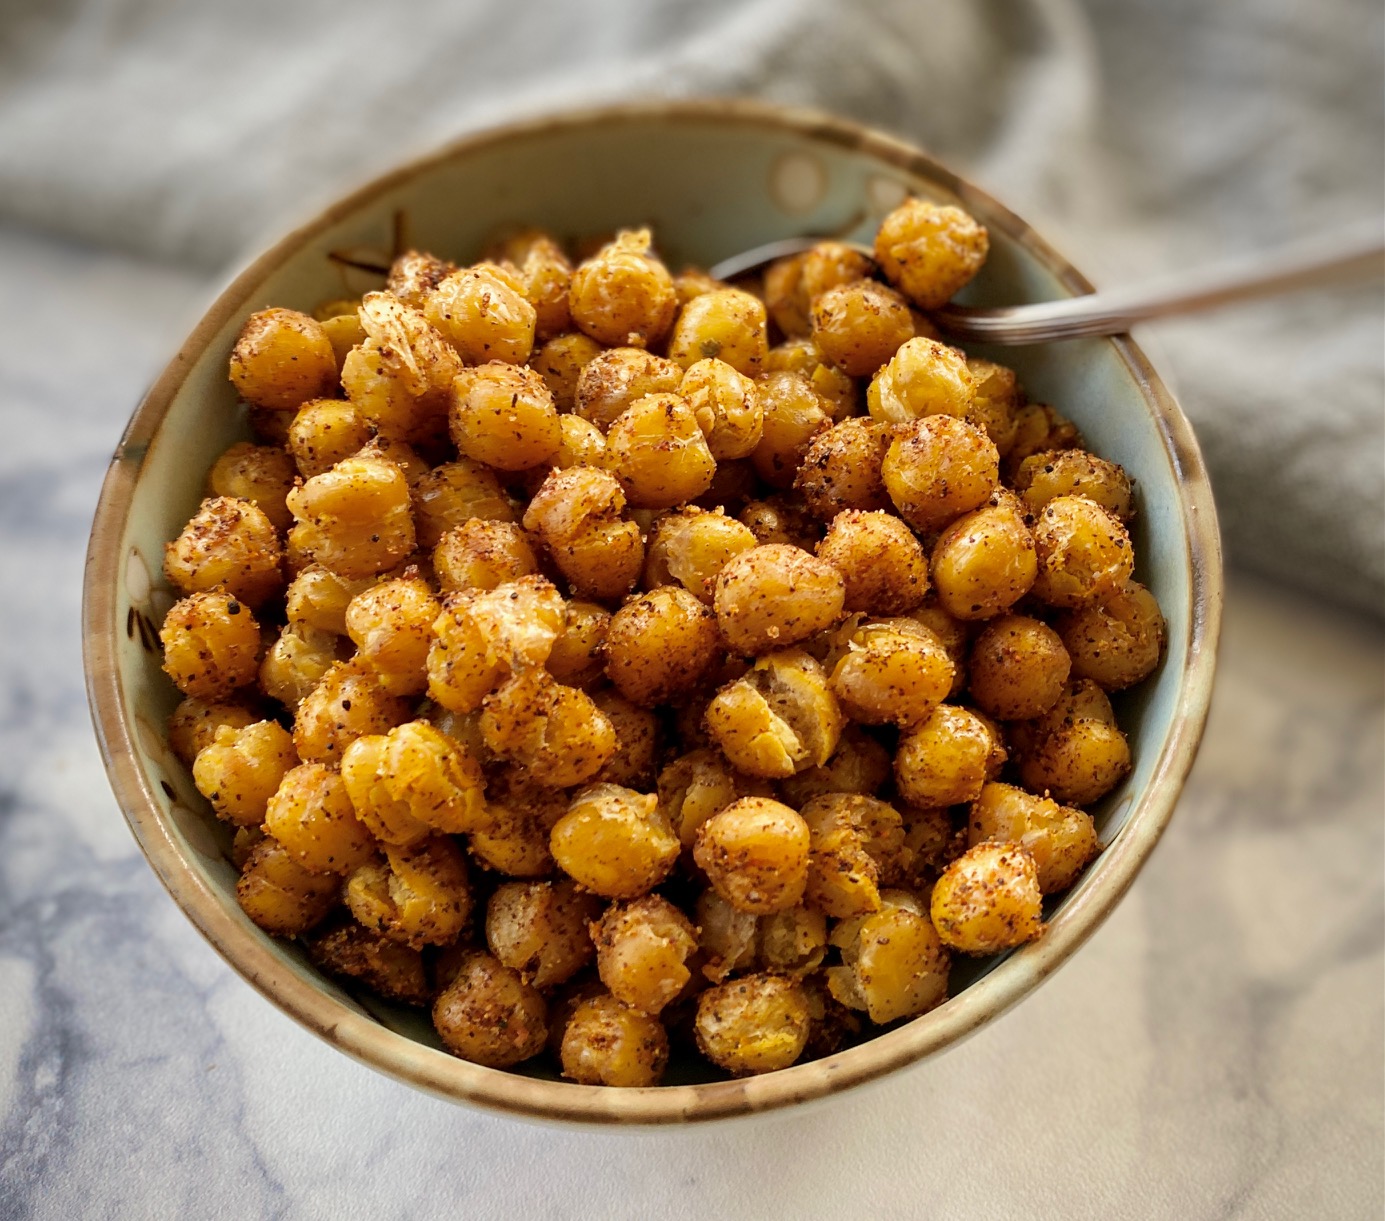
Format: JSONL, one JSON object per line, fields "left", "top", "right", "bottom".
{"left": 0, "top": 221, "right": 1385, "bottom": 1221}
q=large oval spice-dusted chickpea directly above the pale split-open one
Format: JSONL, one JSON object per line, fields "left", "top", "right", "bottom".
{"left": 713, "top": 543, "right": 846, "bottom": 656}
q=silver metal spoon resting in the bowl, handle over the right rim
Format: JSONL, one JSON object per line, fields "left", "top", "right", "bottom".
{"left": 709, "top": 220, "right": 1385, "bottom": 343}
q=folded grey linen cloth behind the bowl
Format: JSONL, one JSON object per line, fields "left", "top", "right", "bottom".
{"left": 0, "top": 0, "right": 1385, "bottom": 615}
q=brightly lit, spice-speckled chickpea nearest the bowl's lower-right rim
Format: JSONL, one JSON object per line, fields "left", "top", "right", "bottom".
{"left": 929, "top": 840, "right": 1043, "bottom": 954}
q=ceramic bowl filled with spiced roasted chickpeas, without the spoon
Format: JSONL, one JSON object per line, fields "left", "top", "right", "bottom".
{"left": 84, "top": 102, "right": 1220, "bottom": 1124}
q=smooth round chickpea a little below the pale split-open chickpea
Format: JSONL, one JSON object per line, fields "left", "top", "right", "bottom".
{"left": 693, "top": 797, "right": 809, "bottom": 915}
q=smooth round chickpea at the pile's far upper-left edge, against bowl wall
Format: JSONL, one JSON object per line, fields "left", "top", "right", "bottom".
{"left": 231, "top": 309, "right": 337, "bottom": 411}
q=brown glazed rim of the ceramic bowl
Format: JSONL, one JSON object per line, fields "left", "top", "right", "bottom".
{"left": 82, "top": 98, "right": 1223, "bottom": 1124}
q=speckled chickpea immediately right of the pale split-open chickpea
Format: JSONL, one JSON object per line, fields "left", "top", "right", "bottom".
{"left": 830, "top": 619, "right": 956, "bottom": 730}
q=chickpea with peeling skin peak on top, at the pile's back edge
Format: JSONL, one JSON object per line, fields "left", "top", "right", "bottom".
{"left": 568, "top": 228, "right": 679, "bottom": 347}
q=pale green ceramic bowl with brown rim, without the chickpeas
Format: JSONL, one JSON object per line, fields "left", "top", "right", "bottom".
{"left": 84, "top": 102, "right": 1222, "bottom": 1124}
